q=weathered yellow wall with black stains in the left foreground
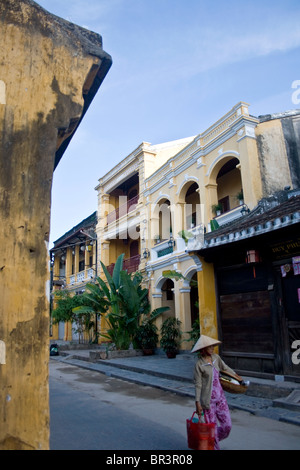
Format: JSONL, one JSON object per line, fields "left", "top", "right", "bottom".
{"left": 0, "top": 0, "right": 111, "bottom": 450}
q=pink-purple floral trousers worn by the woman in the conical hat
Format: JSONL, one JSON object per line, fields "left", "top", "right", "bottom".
{"left": 204, "top": 368, "right": 232, "bottom": 450}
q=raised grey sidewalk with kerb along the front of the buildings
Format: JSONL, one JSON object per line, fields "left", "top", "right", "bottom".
{"left": 51, "top": 349, "right": 300, "bottom": 426}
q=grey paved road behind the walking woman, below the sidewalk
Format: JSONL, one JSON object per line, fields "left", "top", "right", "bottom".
{"left": 49, "top": 360, "right": 300, "bottom": 454}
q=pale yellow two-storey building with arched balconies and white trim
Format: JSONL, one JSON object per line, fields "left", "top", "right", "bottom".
{"left": 144, "top": 103, "right": 262, "bottom": 347}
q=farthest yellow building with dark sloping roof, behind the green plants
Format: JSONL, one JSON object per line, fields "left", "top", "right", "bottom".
{"left": 50, "top": 212, "right": 97, "bottom": 341}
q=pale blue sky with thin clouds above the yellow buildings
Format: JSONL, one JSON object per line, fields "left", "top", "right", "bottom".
{"left": 37, "top": 0, "right": 300, "bottom": 248}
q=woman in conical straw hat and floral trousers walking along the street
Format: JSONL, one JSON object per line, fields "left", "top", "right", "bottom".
{"left": 192, "top": 335, "right": 242, "bottom": 450}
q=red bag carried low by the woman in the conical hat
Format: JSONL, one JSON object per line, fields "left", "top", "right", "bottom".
{"left": 186, "top": 411, "right": 215, "bottom": 450}
